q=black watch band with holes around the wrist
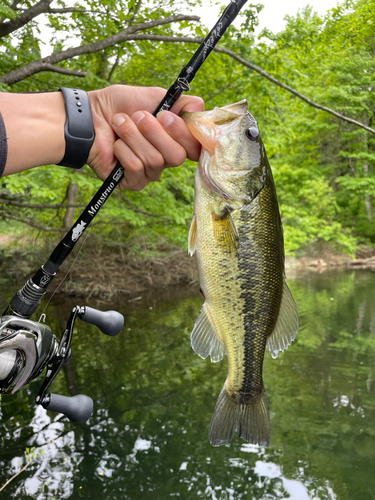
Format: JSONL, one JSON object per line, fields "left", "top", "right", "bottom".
{"left": 58, "top": 87, "right": 95, "bottom": 168}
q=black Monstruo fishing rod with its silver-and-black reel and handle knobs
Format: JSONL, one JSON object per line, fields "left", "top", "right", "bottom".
{"left": 0, "top": 0, "right": 247, "bottom": 422}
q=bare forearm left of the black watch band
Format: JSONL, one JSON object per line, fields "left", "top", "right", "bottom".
{"left": 0, "top": 92, "right": 66, "bottom": 175}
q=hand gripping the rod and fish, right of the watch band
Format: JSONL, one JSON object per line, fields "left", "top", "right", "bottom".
{"left": 87, "top": 85, "right": 204, "bottom": 191}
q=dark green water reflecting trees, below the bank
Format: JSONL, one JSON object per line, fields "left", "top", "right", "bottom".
{"left": 0, "top": 270, "right": 375, "bottom": 500}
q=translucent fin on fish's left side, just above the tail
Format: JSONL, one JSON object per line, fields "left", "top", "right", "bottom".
{"left": 191, "top": 302, "right": 225, "bottom": 363}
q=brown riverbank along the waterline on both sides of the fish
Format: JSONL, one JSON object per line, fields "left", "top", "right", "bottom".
{"left": 0, "top": 239, "right": 375, "bottom": 298}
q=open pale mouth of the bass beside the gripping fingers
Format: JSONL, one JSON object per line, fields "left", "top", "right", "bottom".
{"left": 180, "top": 99, "right": 248, "bottom": 155}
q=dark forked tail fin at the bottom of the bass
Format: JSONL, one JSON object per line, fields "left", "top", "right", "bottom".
{"left": 209, "top": 385, "right": 271, "bottom": 446}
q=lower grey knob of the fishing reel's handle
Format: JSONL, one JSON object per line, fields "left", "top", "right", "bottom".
{"left": 42, "top": 394, "right": 94, "bottom": 423}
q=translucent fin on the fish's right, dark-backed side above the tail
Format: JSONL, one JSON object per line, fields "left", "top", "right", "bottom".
{"left": 266, "top": 280, "right": 298, "bottom": 358}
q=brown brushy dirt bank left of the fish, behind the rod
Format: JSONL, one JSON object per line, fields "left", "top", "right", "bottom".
{"left": 0, "top": 244, "right": 198, "bottom": 298}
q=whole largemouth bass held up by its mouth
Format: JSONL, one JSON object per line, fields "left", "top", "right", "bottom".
{"left": 181, "top": 101, "right": 298, "bottom": 446}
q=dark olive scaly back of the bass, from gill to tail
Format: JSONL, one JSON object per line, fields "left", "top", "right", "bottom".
{"left": 238, "top": 178, "right": 283, "bottom": 403}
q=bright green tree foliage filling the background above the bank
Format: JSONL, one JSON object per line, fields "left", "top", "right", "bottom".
{"left": 0, "top": 0, "right": 375, "bottom": 255}
